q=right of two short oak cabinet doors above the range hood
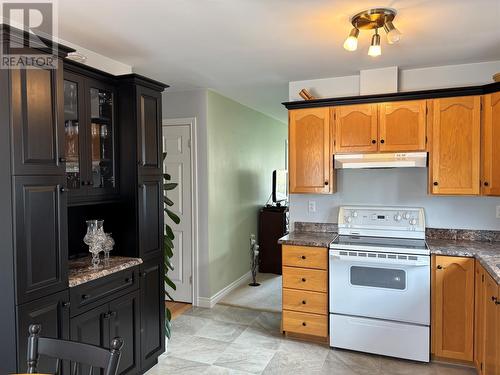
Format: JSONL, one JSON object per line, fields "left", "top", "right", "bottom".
{"left": 379, "top": 100, "right": 427, "bottom": 151}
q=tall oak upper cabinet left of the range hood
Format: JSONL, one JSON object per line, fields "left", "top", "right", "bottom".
{"left": 289, "top": 107, "right": 335, "bottom": 193}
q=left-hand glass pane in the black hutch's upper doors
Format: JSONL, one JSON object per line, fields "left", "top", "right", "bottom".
{"left": 64, "top": 80, "right": 81, "bottom": 190}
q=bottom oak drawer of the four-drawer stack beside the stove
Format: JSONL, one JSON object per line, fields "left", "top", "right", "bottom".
{"left": 283, "top": 310, "right": 328, "bottom": 337}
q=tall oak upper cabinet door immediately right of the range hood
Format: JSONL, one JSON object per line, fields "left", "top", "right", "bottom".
{"left": 429, "top": 96, "right": 481, "bottom": 195}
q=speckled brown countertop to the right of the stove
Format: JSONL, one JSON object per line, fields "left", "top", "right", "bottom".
{"left": 427, "top": 238, "right": 500, "bottom": 284}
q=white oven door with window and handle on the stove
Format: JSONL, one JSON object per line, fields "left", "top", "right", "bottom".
{"left": 329, "top": 250, "right": 430, "bottom": 325}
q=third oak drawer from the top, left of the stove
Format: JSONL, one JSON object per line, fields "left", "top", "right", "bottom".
{"left": 283, "top": 289, "right": 328, "bottom": 315}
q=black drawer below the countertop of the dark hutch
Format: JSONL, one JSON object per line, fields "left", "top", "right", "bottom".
{"left": 70, "top": 266, "right": 139, "bottom": 317}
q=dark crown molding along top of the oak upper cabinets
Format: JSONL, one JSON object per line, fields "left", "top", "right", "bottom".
{"left": 281, "top": 82, "right": 500, "bottom": 109}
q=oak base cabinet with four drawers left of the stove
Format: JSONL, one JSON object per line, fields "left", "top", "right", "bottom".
{"left": 282, "top": 245, "right": 328, "bottom": 338}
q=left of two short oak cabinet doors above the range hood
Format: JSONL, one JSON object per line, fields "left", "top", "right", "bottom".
{"left": 334, "top": 104, "right": 378, "bottom": 153}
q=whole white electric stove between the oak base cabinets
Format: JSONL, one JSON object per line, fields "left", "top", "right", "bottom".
{"left": 329, "top": 206, "right": 430, "bottom": 362}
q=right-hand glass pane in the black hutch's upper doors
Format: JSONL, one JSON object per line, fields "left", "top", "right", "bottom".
{"left": 90, "top": 88, "right": 115, "bottom": 188}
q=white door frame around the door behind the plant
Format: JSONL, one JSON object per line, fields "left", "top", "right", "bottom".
{"left": 162, "top": 117, "right": 200, "bottom": 306}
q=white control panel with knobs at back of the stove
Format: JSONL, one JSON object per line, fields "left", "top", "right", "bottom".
{"left": 338, "top": 206, "right": 425, "bottom": 238}
